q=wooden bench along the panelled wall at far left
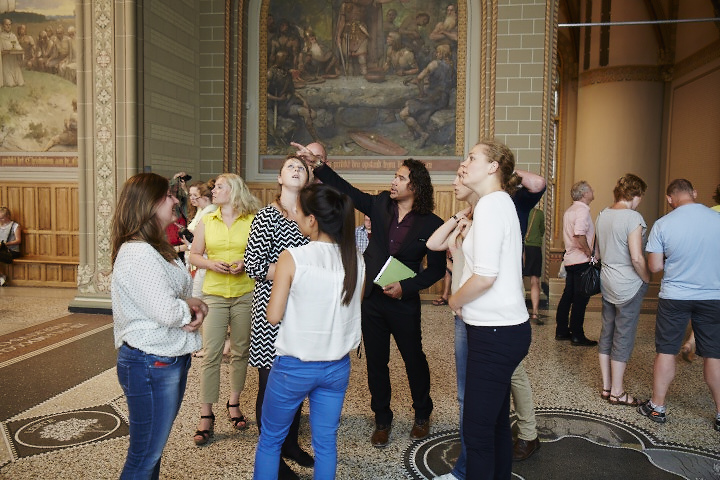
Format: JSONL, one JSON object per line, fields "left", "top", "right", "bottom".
{"left": 4, "top": 255, "right": 79, "bottom": 288}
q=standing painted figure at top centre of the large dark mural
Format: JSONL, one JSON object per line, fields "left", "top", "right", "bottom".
{"left": 335, "top": 0, "right": 391, "bottom": 75}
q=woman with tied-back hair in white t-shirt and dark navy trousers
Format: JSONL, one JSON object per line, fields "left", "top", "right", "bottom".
{"left": 449, "top": 140, "right": 530, "bottom": 479}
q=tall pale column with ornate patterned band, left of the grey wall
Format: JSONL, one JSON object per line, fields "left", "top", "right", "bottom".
{"left": 70, "top": 0, "right": 138, "bottom": 311}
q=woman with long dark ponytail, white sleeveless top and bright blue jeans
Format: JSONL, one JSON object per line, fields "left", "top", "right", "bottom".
{"left": 253, "top": 184, "right": 365, "bottom": 480}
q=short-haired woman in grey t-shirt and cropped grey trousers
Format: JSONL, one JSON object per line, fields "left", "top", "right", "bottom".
{"left": 595, "top": 173, "right": 650, "bottom": 407}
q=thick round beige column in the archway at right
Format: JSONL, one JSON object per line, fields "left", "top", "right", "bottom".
{"left": 562, "top": 2, "right": 665, "bottom": 223}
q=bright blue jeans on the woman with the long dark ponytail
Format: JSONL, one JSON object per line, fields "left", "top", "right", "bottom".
{"left": 253, "top": 355, "right": 350, "bottom": 480}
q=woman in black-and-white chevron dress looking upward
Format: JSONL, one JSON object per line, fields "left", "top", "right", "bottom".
{"left": 245, "top": 155, "right": 313, "bottom": 478}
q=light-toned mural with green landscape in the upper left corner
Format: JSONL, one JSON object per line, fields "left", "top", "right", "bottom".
{"left": 0, "top": 0, "right": 78, "bottom": 155}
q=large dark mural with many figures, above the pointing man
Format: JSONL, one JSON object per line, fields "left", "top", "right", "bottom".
{"left": 260, "top": 0, "right": 465, "bottom": 170}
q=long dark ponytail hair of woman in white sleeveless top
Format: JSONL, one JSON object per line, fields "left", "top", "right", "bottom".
{"left": 300, "top": 183, "right": 358, "bottom": 306}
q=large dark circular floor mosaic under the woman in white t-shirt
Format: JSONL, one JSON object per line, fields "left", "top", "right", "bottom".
{"left": 404, "top": 409, "right": 720, "bottom": 480}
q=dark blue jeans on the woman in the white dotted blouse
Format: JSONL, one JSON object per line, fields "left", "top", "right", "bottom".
{"left": 117, "top": 344, "right": 190, "bottom": 479}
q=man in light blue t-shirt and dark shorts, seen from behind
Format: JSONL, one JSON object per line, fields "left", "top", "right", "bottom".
{"left": 638, "top": 179, "right": 720, "bottom": 431}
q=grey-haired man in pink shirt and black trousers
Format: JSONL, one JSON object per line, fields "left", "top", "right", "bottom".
{"left": 555, "top": 180, "right": 597, "bottom": 347}
